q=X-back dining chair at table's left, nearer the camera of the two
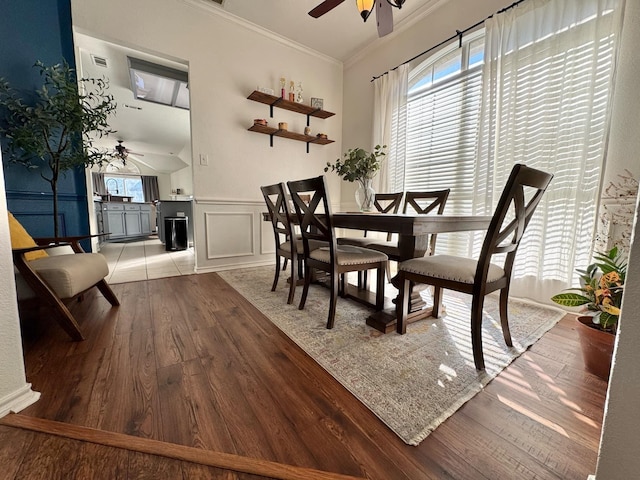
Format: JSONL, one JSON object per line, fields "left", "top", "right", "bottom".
{"left": 287, "top": 175, "right": 387, "bottom": 328}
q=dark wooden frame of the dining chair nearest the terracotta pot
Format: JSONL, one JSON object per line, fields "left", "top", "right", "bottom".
{"left": 397, "top": 164, "right": 553, "bottom": 370}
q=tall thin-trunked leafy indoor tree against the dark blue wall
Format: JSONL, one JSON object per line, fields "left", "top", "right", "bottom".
{"left": 0, "top": 61, "right": 116, "bottom": 237}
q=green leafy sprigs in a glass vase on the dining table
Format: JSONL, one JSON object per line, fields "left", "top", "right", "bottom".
{"left": 324, "top": 145, "right": 387, "bottom": 212}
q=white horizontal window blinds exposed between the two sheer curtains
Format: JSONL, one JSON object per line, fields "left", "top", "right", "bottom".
{"left": 391, "top": 68, "right": 482, "bottom": 254}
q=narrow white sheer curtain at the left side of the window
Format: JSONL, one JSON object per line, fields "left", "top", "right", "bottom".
{"left": 372, "top": 65, "right": 409, "bottom": 193}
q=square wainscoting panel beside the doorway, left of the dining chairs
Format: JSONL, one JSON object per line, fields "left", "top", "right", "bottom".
{"left": 205, "top": 212, "right": 256, "bottom": 260}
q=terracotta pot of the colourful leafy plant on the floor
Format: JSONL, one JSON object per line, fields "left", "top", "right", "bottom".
{"left": 577, "top": 316, "right": 616, "bottom": 380}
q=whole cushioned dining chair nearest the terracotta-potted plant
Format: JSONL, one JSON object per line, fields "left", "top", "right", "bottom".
{"left": 396, "top": 164, "right": 553, "bottom": 370}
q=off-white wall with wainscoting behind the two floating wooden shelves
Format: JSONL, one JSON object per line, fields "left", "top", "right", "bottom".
{"left": 71, "top": 0, "right": 343, "bottom": 272}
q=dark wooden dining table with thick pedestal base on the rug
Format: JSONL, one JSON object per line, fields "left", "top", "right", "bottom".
{"left": 332, "top": 212, "right": 492, "bottom": 333}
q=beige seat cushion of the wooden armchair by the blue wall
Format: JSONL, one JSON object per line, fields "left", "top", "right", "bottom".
{"left": 19, "top": 253, "right": 109, "bottom": 299}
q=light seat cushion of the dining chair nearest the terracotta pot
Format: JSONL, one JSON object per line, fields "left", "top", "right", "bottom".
{"left": 398, "top": 255, "right": 504, "bottom": 284}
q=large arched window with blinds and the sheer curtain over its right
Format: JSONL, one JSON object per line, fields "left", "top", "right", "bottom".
{"left": 389, "top": 0, "right": 623, "bottom": 300}
